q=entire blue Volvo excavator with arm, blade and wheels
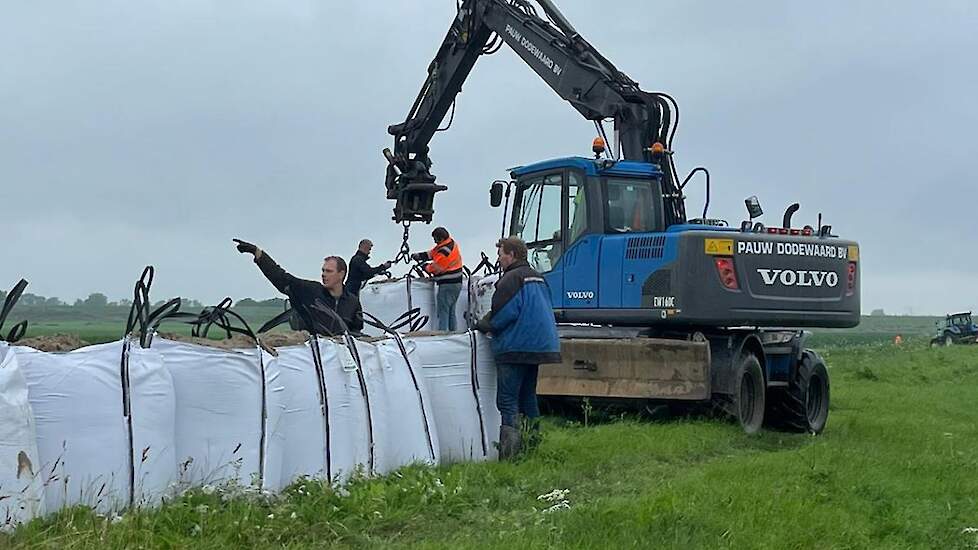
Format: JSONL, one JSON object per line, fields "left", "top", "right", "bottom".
{"left": 384, "top": 0, "right": 860, "bottom": 433}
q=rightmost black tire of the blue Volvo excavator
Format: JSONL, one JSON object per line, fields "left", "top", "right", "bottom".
{"left": 768, "top": 350, "right": 830, "bottom": 434}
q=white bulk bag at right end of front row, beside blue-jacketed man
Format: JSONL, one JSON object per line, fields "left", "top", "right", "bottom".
{"left": 407, "top": 331, "right": 500, "bottom": 463}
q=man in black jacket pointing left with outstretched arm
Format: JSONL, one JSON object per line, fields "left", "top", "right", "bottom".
{"left": 234, "top": 239, "right": 363, "bottom": 336}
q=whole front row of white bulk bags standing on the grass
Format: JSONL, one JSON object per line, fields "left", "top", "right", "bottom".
{"left": 0, "top": 332, "right": 499, "bottom": 525}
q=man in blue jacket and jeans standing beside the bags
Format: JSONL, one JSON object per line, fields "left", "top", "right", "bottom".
{"left": 476, "top": 237, "right": 560, "bottom": 459}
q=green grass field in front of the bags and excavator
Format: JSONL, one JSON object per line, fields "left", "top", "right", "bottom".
{"left": 0, "top": 344, "right": 978, "bottom": 549}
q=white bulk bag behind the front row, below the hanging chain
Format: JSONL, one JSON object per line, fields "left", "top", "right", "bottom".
{"left": 360, "top": 275, "right": 438, "bottom": 336}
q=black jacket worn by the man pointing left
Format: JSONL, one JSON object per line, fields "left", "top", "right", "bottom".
{"left": 255, "top": 251, "right": 363, "bottom": 336}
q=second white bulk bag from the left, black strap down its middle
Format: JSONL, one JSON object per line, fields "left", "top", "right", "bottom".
{"left": 14, "top": 339, "right": 176, "bottom": 512}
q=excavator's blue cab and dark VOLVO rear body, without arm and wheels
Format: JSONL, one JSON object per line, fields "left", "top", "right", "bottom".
{"left": 497, "top": 157, "right": 859, "bottom": 327}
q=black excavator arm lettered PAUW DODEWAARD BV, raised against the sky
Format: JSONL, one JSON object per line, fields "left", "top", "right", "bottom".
{"left": 384, "top": 0, "right": 685, "bottom": 225}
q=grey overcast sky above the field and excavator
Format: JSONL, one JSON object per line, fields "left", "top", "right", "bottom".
{"left": 0, "top": 0, "right": 978, "bottom": 314}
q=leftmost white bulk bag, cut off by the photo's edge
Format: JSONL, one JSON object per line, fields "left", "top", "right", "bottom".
{"left": 0, "top": 342, "right": 44, "bottom": 530}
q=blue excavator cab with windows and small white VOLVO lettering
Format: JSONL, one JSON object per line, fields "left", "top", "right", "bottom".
{"left": 507, "top": 157, "right": 665, "bottom": 309}
